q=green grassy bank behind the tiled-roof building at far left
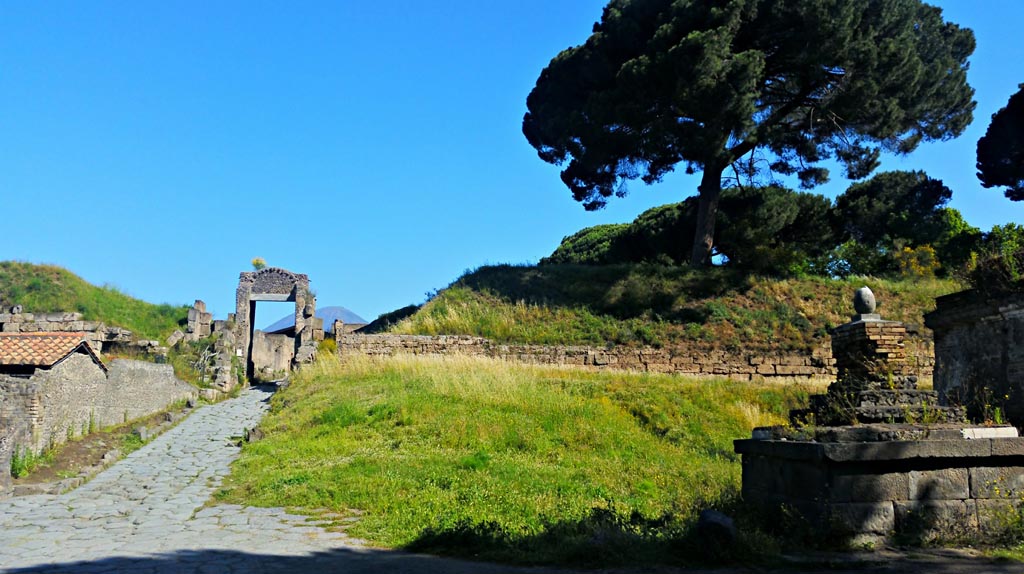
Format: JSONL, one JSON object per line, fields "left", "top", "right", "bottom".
{"left": 0, "top": 261, "right": 188, "bottom": 339}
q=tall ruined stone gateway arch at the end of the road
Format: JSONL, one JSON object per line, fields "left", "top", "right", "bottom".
{"left": 234, "top": 267, "right": 324, "bottom": 381}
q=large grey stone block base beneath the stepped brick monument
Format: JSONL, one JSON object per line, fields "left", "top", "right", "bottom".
{"left": 736, "top": 436, "right": 1024, "bottom": 544}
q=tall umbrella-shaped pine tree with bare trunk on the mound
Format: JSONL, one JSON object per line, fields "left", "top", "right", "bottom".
{"left": 523, "top": 0, "right": 975, "bottom": 265}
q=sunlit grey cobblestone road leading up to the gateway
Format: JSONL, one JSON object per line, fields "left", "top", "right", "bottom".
{"left": 0, "top": 389, "right": 380, "bottom": 572}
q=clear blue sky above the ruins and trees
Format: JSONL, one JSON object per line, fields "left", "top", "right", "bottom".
{"left": 0, "top": 0, "right": 1024, "bottom": 324}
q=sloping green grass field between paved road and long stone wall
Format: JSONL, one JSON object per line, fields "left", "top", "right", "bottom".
{"left": 218, "top": 357, "right": 808, "bottom": 565}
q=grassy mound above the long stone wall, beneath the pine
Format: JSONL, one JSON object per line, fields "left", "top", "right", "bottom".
{"left": 391, "top": 264, "right": 959, "bottom": 351}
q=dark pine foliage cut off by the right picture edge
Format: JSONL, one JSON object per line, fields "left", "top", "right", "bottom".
{"left": 978, "top": 84, "right": 1024, "bottom": 202}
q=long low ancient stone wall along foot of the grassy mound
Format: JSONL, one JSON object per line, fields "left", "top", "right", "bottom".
{"left": 335, "top": 333, "right": 932, "bottom": 381}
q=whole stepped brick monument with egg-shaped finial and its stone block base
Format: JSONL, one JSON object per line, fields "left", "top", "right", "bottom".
{"left": 734, "top": 289, "right": 1024, "bottom": 543}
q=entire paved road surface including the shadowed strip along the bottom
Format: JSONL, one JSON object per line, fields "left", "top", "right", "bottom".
{"left": 0, "top": 389, "right": 1024, "bottom": 574}
